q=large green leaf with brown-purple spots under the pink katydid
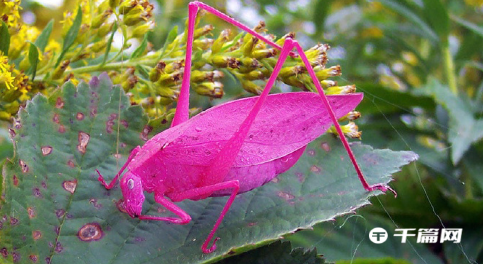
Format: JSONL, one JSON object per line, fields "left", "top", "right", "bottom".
{"left": 0, "top": 75, "right": 417, "bottom": 264}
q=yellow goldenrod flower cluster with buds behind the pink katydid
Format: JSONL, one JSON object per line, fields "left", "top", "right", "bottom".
{"left": 0, "top": 0, "right": 360, "bottom": 137}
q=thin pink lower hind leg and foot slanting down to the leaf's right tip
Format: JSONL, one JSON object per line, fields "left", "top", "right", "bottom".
{"left": 294, "top": 41, "right": 397, "bottom": 196}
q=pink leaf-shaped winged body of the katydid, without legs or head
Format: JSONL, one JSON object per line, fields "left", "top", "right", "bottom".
{"left": 128, "top": 92, "right": 363, "bottom": 196}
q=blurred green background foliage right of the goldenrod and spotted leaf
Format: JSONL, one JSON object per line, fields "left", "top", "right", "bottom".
{"left": 0, "top": 0, "right": 483, "bottom": 263}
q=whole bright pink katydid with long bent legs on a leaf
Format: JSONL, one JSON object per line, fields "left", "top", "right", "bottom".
{"left": 97, "top": 2, "right": 392, "bottom": 253}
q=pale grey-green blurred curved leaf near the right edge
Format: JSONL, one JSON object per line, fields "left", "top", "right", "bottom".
{"left": 421, "top": 78, "right": 483, "bottom": 164}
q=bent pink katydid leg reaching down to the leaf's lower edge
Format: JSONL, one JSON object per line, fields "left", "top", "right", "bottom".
{"left": 169, "top": 180, "right": 240, "bottom": 254}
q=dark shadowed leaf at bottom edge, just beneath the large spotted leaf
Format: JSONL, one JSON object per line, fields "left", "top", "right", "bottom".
{"left": 217, "top": 241, "right": 326, "bottom": 264}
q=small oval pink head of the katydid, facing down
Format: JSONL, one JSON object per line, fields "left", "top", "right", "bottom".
{"left": 121, "top": 171, "right": 144, "bottom": 217}
